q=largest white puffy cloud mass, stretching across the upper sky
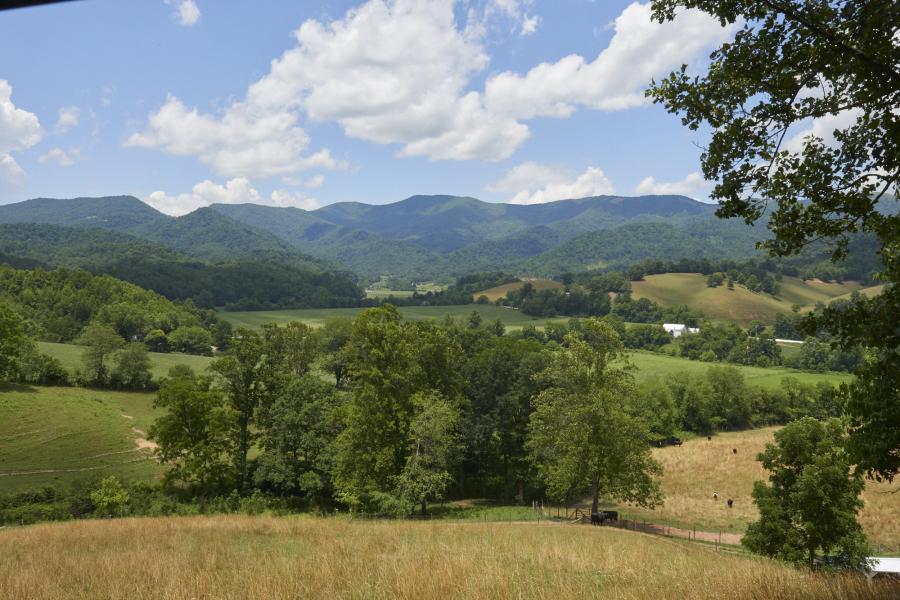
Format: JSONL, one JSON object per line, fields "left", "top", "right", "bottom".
{"left": 127, "top": 0, "right": 729, "bottom": 169}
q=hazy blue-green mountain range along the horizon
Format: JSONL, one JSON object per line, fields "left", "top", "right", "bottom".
{"left": 0, "top": 195, "right": 765, "bottom": 282}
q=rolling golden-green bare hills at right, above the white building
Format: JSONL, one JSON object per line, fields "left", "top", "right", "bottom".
{"left": 632, "top": 273, "right": 861, "bottom": 325}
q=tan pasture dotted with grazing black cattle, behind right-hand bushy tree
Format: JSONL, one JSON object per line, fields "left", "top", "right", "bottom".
{"left": 604, "top": 428, "right": 900, "bottom": 554}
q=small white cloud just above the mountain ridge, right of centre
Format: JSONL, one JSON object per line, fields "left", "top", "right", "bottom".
{"left": 486, "top": 162, "right": 613, "bottom": 204}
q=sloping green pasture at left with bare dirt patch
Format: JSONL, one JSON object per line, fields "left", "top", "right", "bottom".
{"left": 0, "top": 385, "right": 159, "bottom": 493}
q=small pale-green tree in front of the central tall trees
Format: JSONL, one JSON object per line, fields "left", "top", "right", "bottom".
{"left": 397, "top": 391, "right": 461, "bottom": 517}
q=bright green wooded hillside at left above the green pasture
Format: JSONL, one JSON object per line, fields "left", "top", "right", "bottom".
{"left": 0, "top": 265, "right": 231, "bottom": 354}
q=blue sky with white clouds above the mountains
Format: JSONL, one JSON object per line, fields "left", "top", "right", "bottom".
{"left": 0, "top": 0, "right": 733, "bottom": 215}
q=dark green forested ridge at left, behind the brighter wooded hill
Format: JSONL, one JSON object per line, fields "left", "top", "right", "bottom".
{"left": 0, "top": 224, "right": 365, "bottom": 310}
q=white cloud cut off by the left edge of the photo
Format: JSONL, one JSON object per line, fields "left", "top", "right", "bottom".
{"left": 0, "top": 79, "right": 43, "bottom": 193}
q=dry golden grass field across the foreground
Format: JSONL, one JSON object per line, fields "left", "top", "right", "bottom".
{"left": 0, "top": 516, "right": 898, "bottom": 600}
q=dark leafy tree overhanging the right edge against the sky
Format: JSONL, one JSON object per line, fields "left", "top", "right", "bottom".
{"left": 648, "top": 0, "right": 900, "bottom": 479}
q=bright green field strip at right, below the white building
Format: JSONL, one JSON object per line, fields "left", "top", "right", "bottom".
{"left": 629, "top": 352, "right": 853, "bottom": 389}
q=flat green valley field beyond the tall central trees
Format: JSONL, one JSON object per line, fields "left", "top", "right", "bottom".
{"left": 219, "top": 304, "right": 569, "bottom": 329}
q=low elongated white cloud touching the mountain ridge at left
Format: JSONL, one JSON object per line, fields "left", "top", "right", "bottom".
{"left": 145, "top": 177, "right": 320, "bottom": 216}
